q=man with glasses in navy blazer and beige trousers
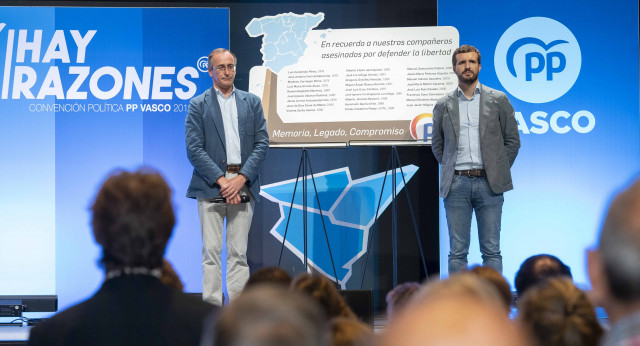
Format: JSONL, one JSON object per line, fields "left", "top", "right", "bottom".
{"left": 186, "top": 48, "right": 269, "bottom": 305}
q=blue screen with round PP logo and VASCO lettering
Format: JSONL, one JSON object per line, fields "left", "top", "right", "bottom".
{"left": 438, "top": 0, "right": 640, "bottom": 287}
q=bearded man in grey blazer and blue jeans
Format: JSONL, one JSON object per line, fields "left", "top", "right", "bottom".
{"left": 431, "top": 45, "right": 520, "bottom": 273}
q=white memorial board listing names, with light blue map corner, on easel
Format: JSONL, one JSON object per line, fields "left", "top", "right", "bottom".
{"left": 246, "top": 20, "right": 458, "bottom": 144}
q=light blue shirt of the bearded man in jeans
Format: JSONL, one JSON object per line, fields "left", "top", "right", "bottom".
{"left": 456, "top": 83, "right": 484, "bottom": 171}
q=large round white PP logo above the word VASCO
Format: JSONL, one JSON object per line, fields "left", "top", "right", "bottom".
{"left": 494, "top": 17, "right": 582, "bottom": 103}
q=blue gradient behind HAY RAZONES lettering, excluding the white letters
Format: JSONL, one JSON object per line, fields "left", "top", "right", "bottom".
{"left": 0, "top": 7, "right": 229, "bottom": 310}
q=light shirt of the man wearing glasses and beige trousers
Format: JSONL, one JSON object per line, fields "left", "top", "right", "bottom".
{"left": 213, "top": 86, "right": 242, "bottom": 165}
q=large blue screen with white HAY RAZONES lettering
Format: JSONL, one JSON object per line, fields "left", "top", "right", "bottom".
{"left": 0, "top": 7, "right": 229, "bottom": 308}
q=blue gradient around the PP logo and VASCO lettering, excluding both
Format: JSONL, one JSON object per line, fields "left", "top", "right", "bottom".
{"left": 438, "top": 0, "right": 640, "bottom": 288}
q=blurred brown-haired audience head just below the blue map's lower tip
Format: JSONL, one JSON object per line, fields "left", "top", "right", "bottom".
{"left": 291, "top": 273, "right": 356, "bottom": 318}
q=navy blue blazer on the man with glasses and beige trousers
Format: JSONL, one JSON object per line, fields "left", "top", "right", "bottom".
{"left": 185, "top": 87, "right": 269, "bottom": 200}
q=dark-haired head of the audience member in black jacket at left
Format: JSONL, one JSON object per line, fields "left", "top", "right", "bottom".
{"left": 91, "top": 169, "right": 175, "bottom": 271}
